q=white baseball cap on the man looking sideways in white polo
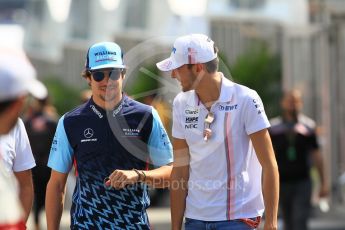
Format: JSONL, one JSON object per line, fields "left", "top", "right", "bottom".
{"left": 156, "top": 34, "right": 217, "bottom": 71}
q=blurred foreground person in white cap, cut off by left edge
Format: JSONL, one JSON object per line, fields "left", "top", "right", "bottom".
{"left": 0, "top": 47, "right": 47, "bottom": 230}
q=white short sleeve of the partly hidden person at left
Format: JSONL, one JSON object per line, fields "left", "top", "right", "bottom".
{"left": 13, "top": 119, "right": 36, "bottom": 172}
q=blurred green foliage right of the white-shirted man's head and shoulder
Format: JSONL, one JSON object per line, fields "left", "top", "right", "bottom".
{"left": 230, "top": 44, "right": 282, "bottom": 117}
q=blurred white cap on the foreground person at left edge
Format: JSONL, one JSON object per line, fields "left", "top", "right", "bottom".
{"left": 0, "top": 47, "right": 48, "bottom": 101}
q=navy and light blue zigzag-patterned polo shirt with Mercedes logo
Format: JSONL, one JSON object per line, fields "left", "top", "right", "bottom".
{"left": 48, "top": 95, "right": 173, "bottom": 229}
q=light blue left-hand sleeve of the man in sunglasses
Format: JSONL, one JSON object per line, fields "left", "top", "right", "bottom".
{"left": 48, "top": 116, "right": 73, "bottom": 173}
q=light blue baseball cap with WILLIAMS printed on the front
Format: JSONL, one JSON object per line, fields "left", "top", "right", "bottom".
{"left": 85, "top": 42, "right": 126, "bottom": 70}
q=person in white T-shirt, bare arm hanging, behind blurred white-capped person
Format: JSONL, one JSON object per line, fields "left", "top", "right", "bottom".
{"left": 0, "top": 118, "right": 36, "bottom": 221}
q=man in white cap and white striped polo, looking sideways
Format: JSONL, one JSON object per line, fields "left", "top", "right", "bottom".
{"left": 157, "top": 34, "right": 279, "bottom": 230}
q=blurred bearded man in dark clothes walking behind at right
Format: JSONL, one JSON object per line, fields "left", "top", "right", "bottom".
{"left": 269, "top": 90, "right": 328, "bottom": 230}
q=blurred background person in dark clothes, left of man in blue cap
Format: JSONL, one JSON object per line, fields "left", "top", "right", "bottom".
{"left": 25, "top": 98, "right": 57, "bottom": 230}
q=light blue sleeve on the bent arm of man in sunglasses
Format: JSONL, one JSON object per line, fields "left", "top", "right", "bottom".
{"left": 148, "top": 108, "right": 173, "bottom": 166}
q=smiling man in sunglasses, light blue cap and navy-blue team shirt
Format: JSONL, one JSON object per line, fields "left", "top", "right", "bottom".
{"left": 46, "top": 42, "right": 172, "bottom": 230}
